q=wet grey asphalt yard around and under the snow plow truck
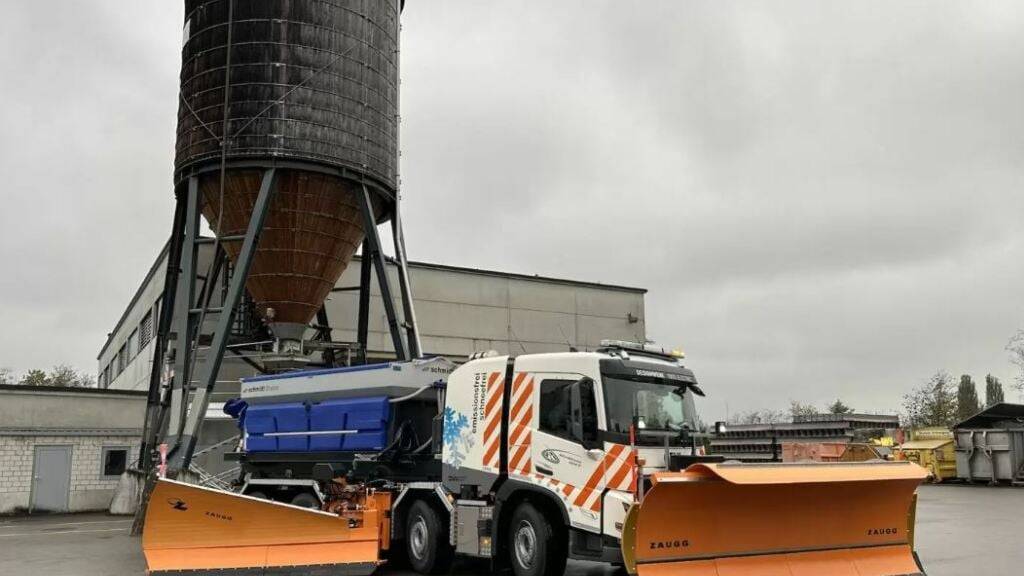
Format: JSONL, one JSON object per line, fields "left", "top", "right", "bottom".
{"left": 0, "top": 485, "right": 1024, "bottom": 576}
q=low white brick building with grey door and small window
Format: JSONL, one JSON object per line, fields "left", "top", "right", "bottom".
{"left": 0, "top": 385, "right": 145, "bottom": 513}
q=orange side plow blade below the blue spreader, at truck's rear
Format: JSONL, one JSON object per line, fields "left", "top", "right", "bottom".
{"left": 142, "top": 480, "right": 390, "bottom": 575}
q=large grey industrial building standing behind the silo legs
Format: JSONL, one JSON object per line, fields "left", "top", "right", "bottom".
{"left": 97, "top": 237, "right": 646, "bottom": 472}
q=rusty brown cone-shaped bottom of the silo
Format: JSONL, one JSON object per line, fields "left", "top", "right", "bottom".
{"left": 200, "top": 169, "right": 364, "bottom": 337}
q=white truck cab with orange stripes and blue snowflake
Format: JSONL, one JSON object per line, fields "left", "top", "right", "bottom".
{"left": 442, "top": 342, "right": 703, "bottom": 575}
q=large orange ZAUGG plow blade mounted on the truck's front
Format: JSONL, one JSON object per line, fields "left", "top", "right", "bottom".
{"left": 623, "top": 462, "right": 928, "bottom": 576}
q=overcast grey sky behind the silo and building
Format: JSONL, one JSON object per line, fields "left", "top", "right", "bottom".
{"left": 0, "top": 0, "right": 1024, "bottom": 420}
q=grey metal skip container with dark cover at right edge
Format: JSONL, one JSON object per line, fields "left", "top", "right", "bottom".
{"left": 953, "top": 403, "right": 1024, "bottom": 484}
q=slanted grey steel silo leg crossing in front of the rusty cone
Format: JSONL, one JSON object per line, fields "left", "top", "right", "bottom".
{"left": 168, "top": 168, "right": 276, "bottom": 470}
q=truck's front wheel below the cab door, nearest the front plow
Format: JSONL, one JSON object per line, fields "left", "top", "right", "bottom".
{"left": 508, "top": 502, "right": 565, "bottom": 576}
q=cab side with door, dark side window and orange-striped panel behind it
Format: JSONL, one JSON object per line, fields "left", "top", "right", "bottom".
{"left": 509, "top": 372, "right": 605, "bottom": 533}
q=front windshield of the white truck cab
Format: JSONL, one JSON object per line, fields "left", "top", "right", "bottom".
{"left": 603, "top": 376, "right": 695, "bottom": 434}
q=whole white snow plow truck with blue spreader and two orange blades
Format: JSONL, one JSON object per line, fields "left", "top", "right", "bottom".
{"left": 143, "top": 341, "right": 927, "bottom": 576}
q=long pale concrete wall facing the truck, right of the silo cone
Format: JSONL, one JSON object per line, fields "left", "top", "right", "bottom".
{"left": 326, "top": 259, "right": 646, "bottom": 358}
